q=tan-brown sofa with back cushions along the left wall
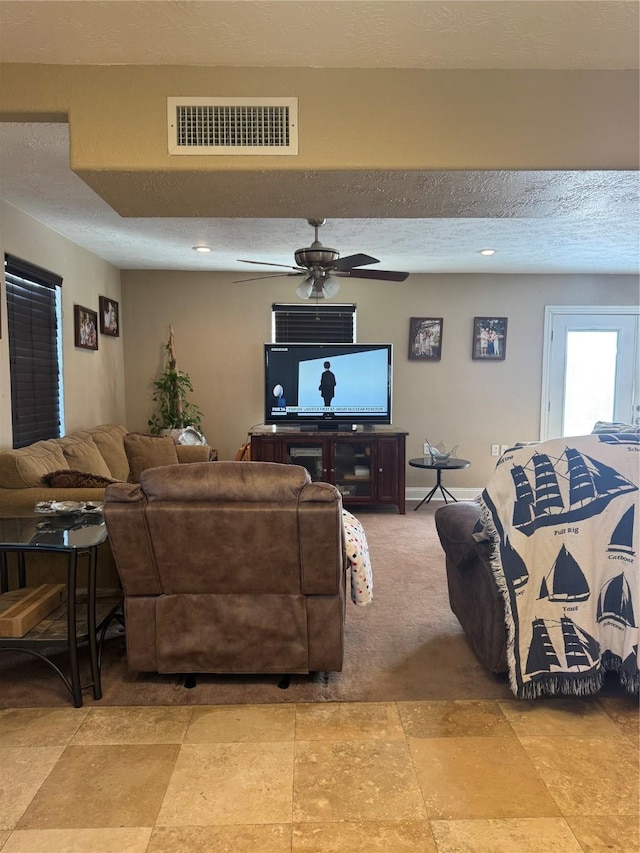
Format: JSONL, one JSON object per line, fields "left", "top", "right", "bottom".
{"left": 0, "top": 424, "right": 211, "bottom": 586}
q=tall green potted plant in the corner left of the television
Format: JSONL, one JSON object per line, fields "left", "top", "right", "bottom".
{"left": 148, "top": 326, "right": 202, "bottom": 441}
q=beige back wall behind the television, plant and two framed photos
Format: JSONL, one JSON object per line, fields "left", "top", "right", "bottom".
{"left": 122, "top": 271, "right": 638, "bottom": 488}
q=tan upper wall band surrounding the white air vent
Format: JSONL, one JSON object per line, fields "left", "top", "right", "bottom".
{"left": 0, "top": 64, "right": 638, "bottom": 170}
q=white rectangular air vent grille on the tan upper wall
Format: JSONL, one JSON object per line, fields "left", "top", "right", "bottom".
{"left": 167, "top": 98, "right": 298, "bottom": 156}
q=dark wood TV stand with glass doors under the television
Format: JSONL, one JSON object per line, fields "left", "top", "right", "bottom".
{"left": 249, "top": 425, "right": 408, "bottom": 515}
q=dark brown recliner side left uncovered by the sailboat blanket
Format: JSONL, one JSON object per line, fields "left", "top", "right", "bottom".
{"left": 434, "top": 501, "right": 508, "bottom": 672}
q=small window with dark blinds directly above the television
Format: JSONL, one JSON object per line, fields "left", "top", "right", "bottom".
{"left": 271, "top": 303, "right": 356, "bottom": 344}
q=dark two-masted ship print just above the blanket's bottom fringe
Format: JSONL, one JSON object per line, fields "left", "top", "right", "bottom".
{"left": 525, "top": 616, "right": 600, "bottom": 675}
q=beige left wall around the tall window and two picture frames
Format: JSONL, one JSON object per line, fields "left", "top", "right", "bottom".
{"left": 0, "top": 202, "right": 125, "bottom": 450}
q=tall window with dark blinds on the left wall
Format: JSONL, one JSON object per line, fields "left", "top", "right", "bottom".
{"left": 5, "top": 254, "right": 63, "bottom": 448}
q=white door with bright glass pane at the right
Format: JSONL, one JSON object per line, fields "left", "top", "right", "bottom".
{"left": 540, "top": 306, "right": 640, "bottom": 440}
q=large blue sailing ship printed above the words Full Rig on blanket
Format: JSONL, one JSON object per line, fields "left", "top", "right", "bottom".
{"left": 511, "top": 447, "right": 638, "bottom": 536}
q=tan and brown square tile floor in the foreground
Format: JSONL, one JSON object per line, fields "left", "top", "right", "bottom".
{"left": 0, "top": 695, "right": 639, "bottom": 853}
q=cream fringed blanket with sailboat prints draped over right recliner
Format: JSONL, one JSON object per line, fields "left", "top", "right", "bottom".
{"left": 478, "top": 432, "right": 640, "bottom": 699}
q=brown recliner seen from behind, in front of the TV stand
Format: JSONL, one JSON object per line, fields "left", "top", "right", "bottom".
{"left": 104, "top": 462, "right": 346, "bottom": 674}
